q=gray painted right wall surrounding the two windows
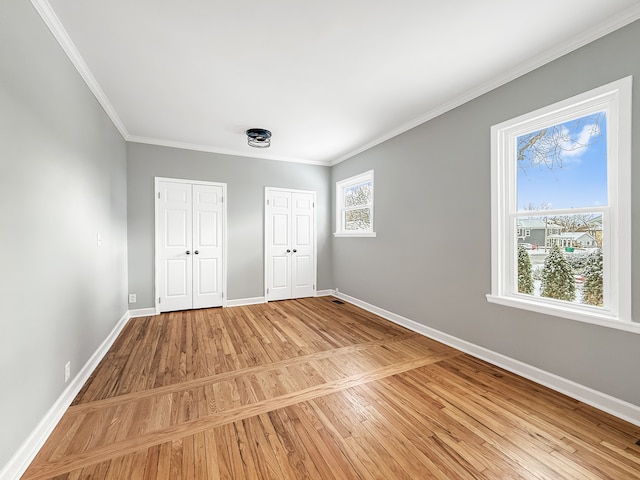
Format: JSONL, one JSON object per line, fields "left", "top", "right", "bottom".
{"left": 332, "top": 22, "right": 640, "bottom": 405}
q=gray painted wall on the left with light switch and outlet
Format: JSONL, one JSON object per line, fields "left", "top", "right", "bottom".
{"left": 0, "top": 0, "right": 127, "bottom": 469}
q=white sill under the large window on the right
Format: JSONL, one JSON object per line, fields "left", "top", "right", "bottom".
{"left": 487, "top": 294, "right": 640, "bottom": 334}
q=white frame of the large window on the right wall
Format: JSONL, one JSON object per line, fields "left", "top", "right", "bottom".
{"left": 487, "top": 77, "right": 640, "bottom": 333}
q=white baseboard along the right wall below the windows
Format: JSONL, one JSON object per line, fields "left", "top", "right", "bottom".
{"left": 335, "top": 292, "right": 640, "bottom": 426}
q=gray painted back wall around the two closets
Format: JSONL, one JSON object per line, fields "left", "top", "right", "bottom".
{"left": 127, "top": 143, "right": 333, "bottom": 309}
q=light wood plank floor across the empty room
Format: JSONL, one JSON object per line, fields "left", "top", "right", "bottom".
{"left": 23, "top": 297, "right": 640, "bottom": 480}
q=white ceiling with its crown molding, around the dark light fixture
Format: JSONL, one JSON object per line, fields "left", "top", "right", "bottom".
{"left": 32, "top": 0, "right": 640, "bottom": 165}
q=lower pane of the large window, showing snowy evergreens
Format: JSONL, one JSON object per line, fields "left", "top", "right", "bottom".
{"left": 515, "top": 212, "right": 603, "bottom": 307}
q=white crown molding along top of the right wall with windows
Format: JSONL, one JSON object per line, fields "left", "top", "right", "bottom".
{"left": 329, "top": 5, "right": 640, "bottom": 166}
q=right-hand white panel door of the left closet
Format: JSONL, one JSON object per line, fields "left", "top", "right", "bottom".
{"left": 192, "top": 185, "right": 222, "bottom": 308}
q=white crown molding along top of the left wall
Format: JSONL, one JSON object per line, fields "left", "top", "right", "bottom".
{"left": 31, "top": 0, "right": 129, "bottom": 140}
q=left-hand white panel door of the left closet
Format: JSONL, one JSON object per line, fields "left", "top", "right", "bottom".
{"left": 156, "top": 182, "right": 193, "bottom": 311}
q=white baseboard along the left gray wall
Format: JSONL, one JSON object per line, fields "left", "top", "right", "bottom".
{"left": 0, "top": 312, "right": 131, "bottom": 479}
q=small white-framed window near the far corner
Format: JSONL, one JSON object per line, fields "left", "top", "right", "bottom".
{"left": 334, "top": 170, "right": 376, "bottom": 237}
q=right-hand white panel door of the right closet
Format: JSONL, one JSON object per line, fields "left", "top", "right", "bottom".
{"left": 291, "top": 192, "right": 316, "bottom": 298}
